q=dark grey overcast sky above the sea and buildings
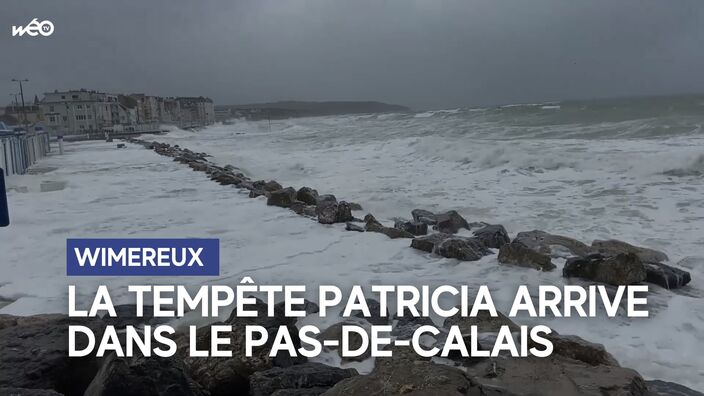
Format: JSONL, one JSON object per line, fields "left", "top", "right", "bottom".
{"left": 0, "top": 0, "right": 704, "bottom": 109}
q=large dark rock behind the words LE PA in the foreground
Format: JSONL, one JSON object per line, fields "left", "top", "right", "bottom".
{"left": 179, "top": 301, "right": 306, "bottom": 396}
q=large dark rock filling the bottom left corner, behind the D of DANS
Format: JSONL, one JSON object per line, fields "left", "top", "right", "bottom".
{"left": 0, "top": 315, "right": 105, "bottom": 396}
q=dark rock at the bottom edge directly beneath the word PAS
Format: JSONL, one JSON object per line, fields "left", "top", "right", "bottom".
{"left": 249, "top": 363, "right": 358, "bottom": 396}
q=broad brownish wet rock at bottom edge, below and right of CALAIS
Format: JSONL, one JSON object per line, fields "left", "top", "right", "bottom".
{"left": 465, "top": 356, "right": 647, "bottom": 396}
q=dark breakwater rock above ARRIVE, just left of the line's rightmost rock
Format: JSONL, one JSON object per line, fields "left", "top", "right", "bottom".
{"left": 562, "top": 253, "right": 646, "bottom": 286}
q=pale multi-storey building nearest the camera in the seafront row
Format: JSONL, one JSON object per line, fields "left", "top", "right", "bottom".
{"left": 40, "top": 89, "right": 137, "bottom": 135}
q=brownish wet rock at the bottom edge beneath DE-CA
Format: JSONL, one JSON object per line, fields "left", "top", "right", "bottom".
{"left": 324, "top": 358, "right": 472, "bottom": 396}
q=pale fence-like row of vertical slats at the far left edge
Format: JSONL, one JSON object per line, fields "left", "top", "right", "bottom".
{"left": 0, "top": 132, "right": 51, "bottom": 176}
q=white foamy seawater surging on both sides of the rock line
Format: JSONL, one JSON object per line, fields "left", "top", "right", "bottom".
{"left": 0, "top": 95, "right": 704, "bottom": 390}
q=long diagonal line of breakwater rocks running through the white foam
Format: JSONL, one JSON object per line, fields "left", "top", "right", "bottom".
{"left": 129, "top": 139, "right": 691, "bottom": 289}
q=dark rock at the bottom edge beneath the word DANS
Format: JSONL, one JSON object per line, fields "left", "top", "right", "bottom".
{"left": 85, "top": 354, "right": 207, "bottom": 396}
